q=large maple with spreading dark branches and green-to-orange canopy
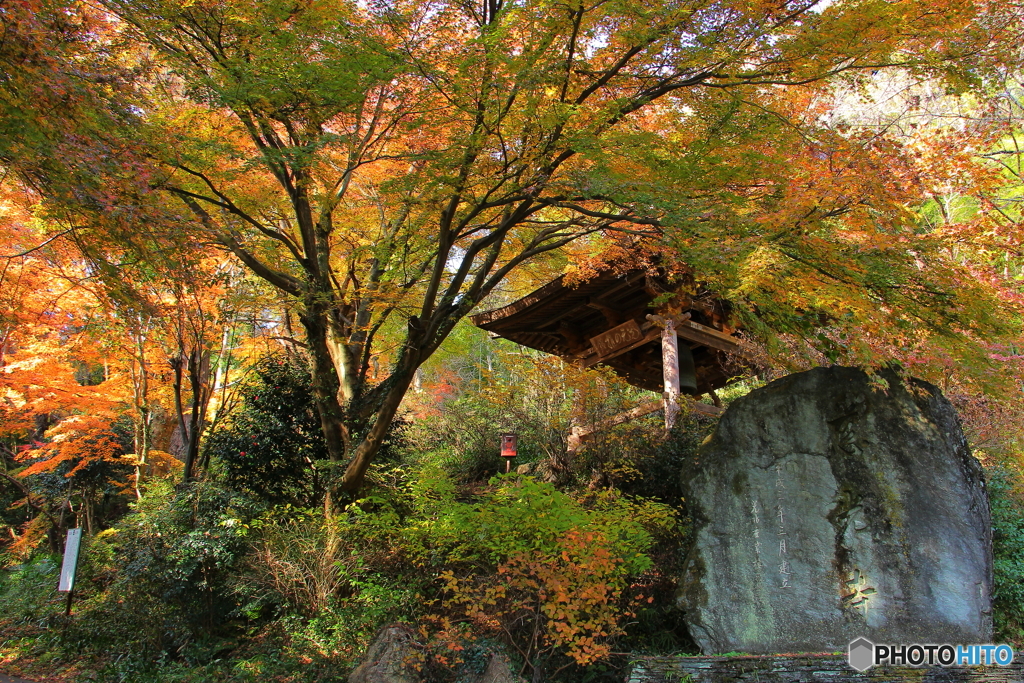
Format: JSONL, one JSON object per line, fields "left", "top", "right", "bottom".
{"left": 8, "top": 0, "right": 1021, "bottom": 510}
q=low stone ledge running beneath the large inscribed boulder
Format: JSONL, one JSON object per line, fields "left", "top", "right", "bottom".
{"left": 627, "top": 655, "right": 1024, "bottom": 683}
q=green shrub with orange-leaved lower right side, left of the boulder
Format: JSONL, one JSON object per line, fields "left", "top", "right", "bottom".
{"left": 407, "top": 474, "right": 675, "bottom": 675}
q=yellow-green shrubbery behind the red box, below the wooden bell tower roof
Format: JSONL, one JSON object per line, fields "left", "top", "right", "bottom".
{"left": 406, "top": 352, "right": 663, "bottom": 486}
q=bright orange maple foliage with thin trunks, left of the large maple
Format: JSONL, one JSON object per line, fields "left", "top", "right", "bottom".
{"left": 0, "top": 188, "right": 276, "bottom": 557}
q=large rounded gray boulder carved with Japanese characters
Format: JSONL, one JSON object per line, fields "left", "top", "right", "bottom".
{"left": 679, "top": 368, "right": 992, "bottom": 653}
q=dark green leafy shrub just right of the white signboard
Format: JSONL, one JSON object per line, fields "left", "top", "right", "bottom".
{"left": 26, "top": 482, "right": 268, "bottom": 680}
